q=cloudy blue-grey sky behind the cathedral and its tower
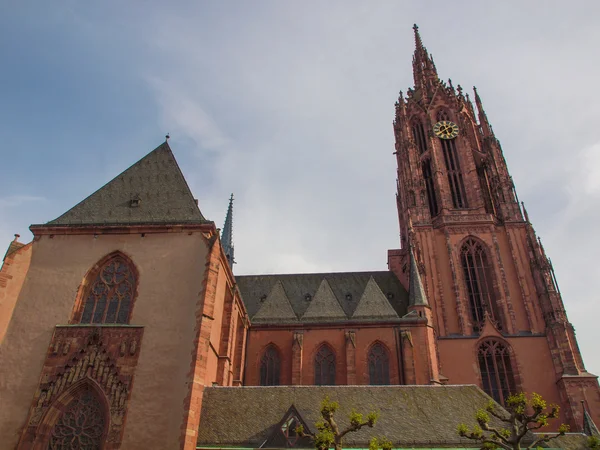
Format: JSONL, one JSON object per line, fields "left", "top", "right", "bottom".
{"left": 0, "top": 0, "right": 600, "bottom": 373}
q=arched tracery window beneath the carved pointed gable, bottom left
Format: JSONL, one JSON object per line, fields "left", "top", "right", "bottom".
{"left": 48, "top": 389, "right": 106, "bottom": 450}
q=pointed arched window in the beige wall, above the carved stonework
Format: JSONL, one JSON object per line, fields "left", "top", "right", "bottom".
{"left": 79, "top": 254, "right": 136, "bottom": 323}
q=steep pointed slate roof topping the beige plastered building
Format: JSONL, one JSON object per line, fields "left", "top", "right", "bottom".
{"left": 42, "top": 142, "right": 207, "bottom": 226}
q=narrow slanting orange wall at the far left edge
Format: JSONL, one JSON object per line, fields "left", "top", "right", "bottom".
{"left": 0, "top": 244, "right": 32, "bottom": 343}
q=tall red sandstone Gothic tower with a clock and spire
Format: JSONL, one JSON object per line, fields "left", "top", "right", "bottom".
{"left": 388, "top": 25, "right": 600, "bottom": 431}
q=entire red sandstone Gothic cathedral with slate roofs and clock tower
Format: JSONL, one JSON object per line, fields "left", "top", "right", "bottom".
{"left": 0, "top": 25, "right": 600, "bottom": 450}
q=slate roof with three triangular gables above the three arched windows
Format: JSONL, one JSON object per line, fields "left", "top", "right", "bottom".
{"left": 236, "top": 271, "right": 408, "bottom": 324}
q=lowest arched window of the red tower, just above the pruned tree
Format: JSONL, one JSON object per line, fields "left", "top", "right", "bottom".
{"left": 477, "top": 340, "right": 516, "bottom": 404}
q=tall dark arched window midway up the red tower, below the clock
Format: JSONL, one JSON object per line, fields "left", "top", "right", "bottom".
{"left": 460, "top": 238, "right": 502, "bottom": 333}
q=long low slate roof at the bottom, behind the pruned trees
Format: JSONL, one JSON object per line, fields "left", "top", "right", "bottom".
{"left": 197, "top": 385, "right": 506, "bottom": 448}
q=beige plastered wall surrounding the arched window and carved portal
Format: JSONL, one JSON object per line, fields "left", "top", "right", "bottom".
{"left": 0, "top": 232, "right": 207, "bottom": 449}
